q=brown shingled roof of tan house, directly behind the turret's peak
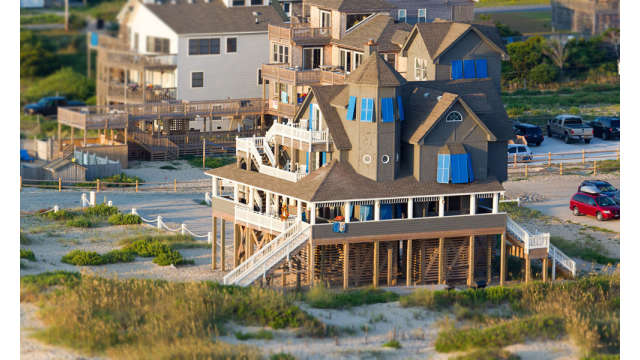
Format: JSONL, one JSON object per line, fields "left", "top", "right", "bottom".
{"left": 332, "top": 14, "right": 411, "bottom": 52}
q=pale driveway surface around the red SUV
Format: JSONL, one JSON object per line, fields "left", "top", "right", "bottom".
{"left": 504, "top": 175, "right": 620, "bottom": 232}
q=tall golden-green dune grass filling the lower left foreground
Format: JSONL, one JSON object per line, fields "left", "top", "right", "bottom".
{"left": 21, "top": 272, "right": 334, "bottom": 359}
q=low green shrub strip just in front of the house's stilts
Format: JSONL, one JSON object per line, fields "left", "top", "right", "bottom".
{"left": 305, "top": 286, "right": 399, "bottom": 309}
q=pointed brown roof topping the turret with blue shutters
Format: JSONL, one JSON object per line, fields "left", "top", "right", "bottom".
{"left": 344, "top": 52, "right": 407, "bottom": 86}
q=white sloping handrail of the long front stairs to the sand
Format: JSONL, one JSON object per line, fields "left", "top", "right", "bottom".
{"left": 223, "top": 221, "right": 310, "bottom": 285}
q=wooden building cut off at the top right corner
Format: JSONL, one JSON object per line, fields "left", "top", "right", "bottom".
{"left": 551, "top": 0, "right": 620, "bottom": 35}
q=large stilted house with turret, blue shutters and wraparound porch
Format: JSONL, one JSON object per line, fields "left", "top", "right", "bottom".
{"left": 207, "top": 43, "right": 572, "bottom": 287}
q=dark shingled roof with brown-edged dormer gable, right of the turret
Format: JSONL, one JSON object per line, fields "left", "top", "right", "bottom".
{"left": 403, "top": 79, "right": 513, "bottom": 143}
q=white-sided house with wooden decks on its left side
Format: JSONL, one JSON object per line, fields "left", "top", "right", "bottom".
{"left": 92, "top": 0, "right": 285, "bottom": 105}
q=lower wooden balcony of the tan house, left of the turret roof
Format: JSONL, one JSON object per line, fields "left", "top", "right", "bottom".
{"left": 262, "top": 64, "right": 345, "bottom": 86}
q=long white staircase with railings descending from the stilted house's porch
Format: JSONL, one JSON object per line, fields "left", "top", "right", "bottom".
{"left": 223, "top": 222, "right": 311, "bottom": 286}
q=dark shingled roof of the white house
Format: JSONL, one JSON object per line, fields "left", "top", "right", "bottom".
{"left": 144, "top": 0, "right": 284, "bottom": 34}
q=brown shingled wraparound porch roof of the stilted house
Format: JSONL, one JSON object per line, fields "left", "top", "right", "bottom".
{"left": 206, "top": 160, "right": 504, "bottom": 202}
